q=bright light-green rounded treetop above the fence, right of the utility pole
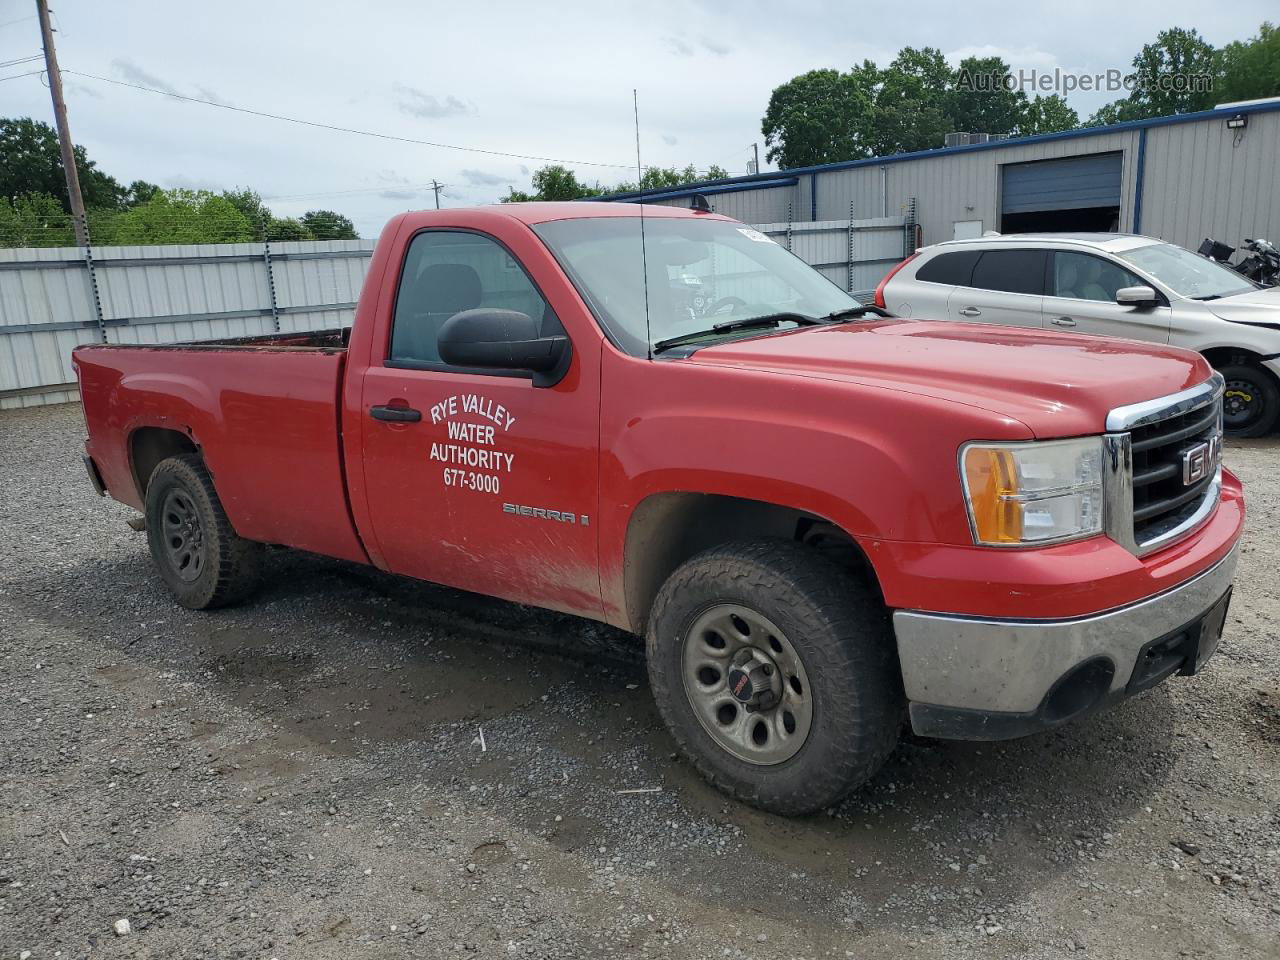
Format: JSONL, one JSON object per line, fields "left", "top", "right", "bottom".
{"left": 110, "top": 189, "right": 262, "bottom": 244}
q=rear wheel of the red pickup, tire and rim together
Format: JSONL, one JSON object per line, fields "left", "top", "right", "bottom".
{"left": 146, "top": 454, "right": 264, "bottom": 611}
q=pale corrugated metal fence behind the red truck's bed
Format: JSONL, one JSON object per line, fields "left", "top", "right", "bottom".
{"left": 0, "top": 239, "right": 374, "bottom": 410}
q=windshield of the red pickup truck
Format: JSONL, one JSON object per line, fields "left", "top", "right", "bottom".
{"left": 534, "top": 216, "right": 860, "bottom": 357}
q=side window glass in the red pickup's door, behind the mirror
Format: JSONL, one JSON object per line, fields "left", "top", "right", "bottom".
{"left": 388, "top": 230, "right": 562, "bottom": 366}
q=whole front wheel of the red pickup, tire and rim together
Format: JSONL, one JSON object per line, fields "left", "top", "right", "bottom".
{"left": 646, "top": 540, "right": 902, "bottom": 815}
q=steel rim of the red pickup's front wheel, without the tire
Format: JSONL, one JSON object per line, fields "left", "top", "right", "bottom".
{"left": 681, "top": 603, "right": 813, "bottom": 767}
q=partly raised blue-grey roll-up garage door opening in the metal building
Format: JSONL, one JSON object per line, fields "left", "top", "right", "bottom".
{"left": 1000, "top": 151, "right": 1124, "bottom": 233}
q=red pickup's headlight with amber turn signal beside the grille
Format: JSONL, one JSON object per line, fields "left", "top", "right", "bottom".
{"left": 960, "top": 436, "right": 1103, "bottom": 547}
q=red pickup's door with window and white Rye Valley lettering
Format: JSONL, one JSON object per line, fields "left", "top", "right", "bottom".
{"left": 361, "top": 229, "right": 600, "bottom": 613}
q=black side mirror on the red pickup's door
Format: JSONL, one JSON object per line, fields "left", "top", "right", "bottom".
{"left": 436, "top": 307, "right": 571, "bottom": 387}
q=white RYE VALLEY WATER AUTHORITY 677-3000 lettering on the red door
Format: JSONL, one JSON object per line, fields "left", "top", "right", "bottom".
{"left": 429, "top": 393, "right": 516, "bottom": 494}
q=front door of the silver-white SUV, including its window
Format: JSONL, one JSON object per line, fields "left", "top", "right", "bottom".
{"left": 1044, "top": 251, "right": 1172, "bottom": 343}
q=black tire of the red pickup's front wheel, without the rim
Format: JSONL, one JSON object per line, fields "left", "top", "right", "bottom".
{"left": 646, "top": 540, "right": 902, "bottom": 815}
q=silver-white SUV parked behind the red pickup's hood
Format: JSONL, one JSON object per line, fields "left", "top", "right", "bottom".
{"left": 876, "top": 233, "right": 1280, "bottom": 436}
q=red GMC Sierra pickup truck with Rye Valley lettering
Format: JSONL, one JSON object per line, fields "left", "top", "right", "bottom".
{"left": 74, "top": 204, "right": 1244, "bottom": 814}
